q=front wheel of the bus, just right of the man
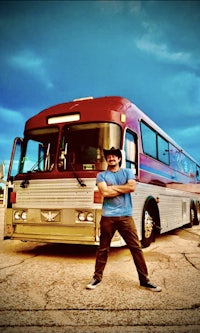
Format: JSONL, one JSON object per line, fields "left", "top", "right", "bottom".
{"left": 141, "top": 196, "right": 160, "bottom": 248}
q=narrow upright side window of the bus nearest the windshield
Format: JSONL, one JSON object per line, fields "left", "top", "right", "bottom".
{"left": 124, "top": 131, "right": 138, "bottom": 175}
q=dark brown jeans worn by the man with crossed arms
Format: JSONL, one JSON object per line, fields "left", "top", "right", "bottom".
{"left": 94, "top": 216, "right": 149, "bottom": 284}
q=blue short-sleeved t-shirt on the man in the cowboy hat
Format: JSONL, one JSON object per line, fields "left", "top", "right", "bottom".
{"left": 97, "top": 168, "right": 134, "bottom": 216}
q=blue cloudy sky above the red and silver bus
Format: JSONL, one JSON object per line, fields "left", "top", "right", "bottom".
{"left": 0, "top": 1, "right": 200, "bottom": 176}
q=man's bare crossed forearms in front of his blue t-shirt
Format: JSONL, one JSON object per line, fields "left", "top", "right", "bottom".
{"left": 97, "top": 179, "right": 136, "bottom": 198}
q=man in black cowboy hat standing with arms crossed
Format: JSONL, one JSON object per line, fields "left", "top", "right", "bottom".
{"left": 86, "top": 147, "right": 162, "bottom": 291}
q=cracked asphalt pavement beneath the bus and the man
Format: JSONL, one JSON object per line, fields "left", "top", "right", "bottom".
{"left": 0, "top": 222, "right": 200, "bottom": 333}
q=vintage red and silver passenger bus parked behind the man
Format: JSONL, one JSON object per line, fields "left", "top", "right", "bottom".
{"left": 4, "top": 96, "right": 200, "bottom": 248}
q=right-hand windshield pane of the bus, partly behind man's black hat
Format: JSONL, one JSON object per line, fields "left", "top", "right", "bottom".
{"left": 58, "top": 123, "right": 121, "bottom": 171}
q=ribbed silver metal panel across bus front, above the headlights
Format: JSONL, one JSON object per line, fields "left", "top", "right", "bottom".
{"left": 13, "top": 179, "right": 95, "bottom": 208}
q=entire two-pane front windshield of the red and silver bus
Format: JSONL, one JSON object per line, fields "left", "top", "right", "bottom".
{"left": 19, "top": 123, "right": 121, "bottom": 173}
